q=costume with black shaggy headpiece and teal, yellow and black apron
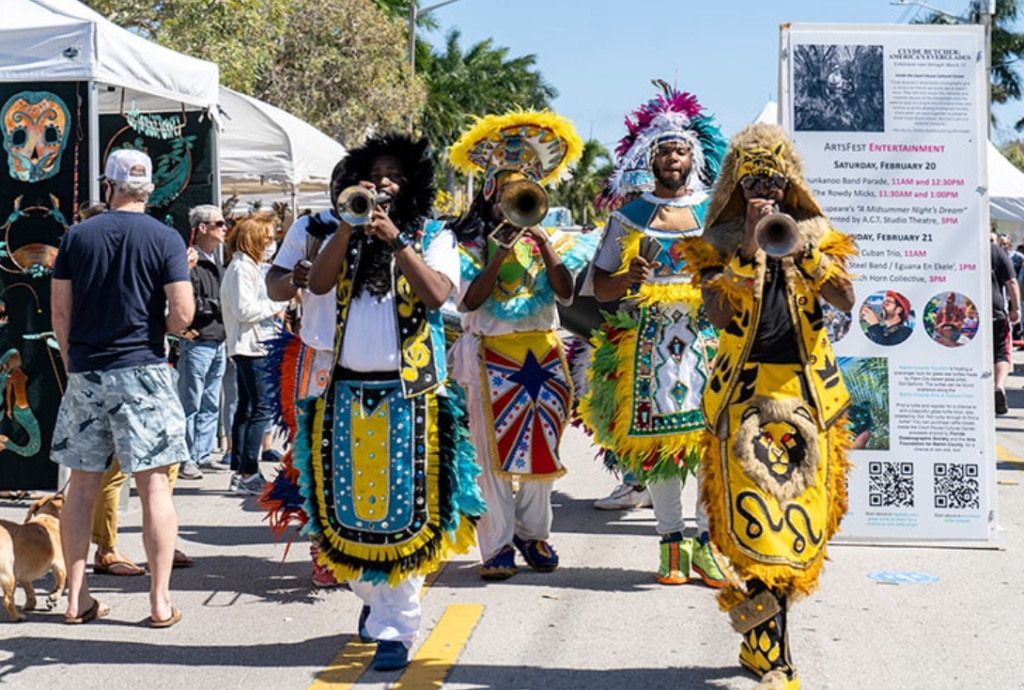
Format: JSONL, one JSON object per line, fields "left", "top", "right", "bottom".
{"left": 258, "top": 136, "right": 484, "bottom": 630}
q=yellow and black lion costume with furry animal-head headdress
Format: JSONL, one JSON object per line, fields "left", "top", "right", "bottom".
{"left": 685, "top": 125, "right": 855, "bottom": 688}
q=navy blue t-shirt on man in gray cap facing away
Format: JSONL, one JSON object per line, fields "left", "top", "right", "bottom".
{"left": 53, "top": 211, "right": 188, "bottom": 373}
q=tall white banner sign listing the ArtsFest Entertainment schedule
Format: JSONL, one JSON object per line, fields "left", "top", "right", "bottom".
{"left": 779, "top": 25, "right": 997, "bottom": 546}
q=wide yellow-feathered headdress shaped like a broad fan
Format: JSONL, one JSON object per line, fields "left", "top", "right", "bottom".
{"left": 449, "top": 111, "right": 583, "bottom": 199}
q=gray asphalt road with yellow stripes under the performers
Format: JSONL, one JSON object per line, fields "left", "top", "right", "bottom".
{"left": 0, "top": 360, "right": 1024, "bottom": 690}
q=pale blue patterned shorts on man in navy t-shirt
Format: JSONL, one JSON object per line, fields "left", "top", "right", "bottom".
{"left": 50, "top": 364, "right": 188, "bottom": 474}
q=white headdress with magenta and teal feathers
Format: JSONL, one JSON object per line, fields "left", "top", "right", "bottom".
{"left": 598, "top": 80, "right": 727, "bottom": 207}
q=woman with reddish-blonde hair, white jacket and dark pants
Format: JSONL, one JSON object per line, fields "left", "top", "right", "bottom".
{"left": 220, "top": 213, "right": 288, "bottom": 493}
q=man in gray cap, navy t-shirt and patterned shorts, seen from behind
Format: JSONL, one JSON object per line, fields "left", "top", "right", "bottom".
{"left": 51, "top": 149, "right": 196, "bottom": 628}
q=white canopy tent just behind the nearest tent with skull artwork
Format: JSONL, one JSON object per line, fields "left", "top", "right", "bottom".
{"left": 220, "top": 87, "right": 346, "bottom": 215}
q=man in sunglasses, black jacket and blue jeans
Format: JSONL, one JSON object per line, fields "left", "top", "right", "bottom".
{"left": 177, "top": 205, "right": 227, "bottom": 479}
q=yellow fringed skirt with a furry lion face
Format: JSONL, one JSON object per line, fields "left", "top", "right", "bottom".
{"left": 700, "top": 362, "right": 852, "bottom": 596}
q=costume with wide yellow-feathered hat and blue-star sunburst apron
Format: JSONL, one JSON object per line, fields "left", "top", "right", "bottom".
{"left": 451, "top": 112, "right": 597, "bottom": 579}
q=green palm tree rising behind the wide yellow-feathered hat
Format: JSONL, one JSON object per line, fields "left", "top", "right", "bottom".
{"left": 416, "top": 30, "right": 558, "bottom": 191}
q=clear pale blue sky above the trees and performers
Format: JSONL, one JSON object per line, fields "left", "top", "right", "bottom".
{"left": 420, "top": 0, "right": 1024, "bottom": 149}
